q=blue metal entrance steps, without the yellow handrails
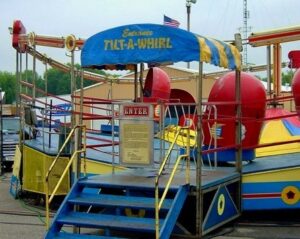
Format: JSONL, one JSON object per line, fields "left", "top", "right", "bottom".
{"left": 45, "top": 178, "right": 189, "bottom": 239}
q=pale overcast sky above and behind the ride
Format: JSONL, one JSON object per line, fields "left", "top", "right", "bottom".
{"left": 0, "top": 0, "right": 300, "bottom": 74}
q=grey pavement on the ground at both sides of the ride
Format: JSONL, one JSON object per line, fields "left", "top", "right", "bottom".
{"left": 0, "top": 173, "right": 300, "bottom": 239}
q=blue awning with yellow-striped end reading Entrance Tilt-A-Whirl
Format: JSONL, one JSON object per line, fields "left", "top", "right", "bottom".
{"left": 81, "top": 24, "right": 241, "bottom": 70}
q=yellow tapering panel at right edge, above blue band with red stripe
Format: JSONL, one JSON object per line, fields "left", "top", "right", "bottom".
{"left": 242, "top": 167, "right": 300, "bottom": 183}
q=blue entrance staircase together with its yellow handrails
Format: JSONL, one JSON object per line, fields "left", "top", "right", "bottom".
{"left": 45, "top": 128, "right": 190, "bottom": 239}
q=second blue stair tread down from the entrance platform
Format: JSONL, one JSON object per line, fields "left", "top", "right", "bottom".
{"left": 68, "top": 193, "right": 173, "bottom": 210}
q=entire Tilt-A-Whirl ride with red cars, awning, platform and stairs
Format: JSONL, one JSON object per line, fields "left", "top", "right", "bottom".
{"left": 11, "top": 21, "right": 300, "bottom": 238}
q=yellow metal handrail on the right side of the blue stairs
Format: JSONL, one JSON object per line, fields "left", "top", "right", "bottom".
{"left": 155, "top": 126, "right": 190, "bottom": 239}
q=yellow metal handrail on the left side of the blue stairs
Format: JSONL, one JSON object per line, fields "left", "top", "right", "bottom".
{"left": 45, "top": 125, "right": 86, "bottom": 230}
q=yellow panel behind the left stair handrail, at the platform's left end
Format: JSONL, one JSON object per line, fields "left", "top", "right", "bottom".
{"left": 23, "top": 145, "right": 70, "bottom": 195}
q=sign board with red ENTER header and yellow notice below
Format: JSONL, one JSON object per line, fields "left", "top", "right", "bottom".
{"left": 120, "top": 104, "right": 154, "bottom": 167}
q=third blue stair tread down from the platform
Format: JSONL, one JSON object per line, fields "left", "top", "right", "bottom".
{"left": 56, "top": 212, "right": 164, "bottom": 233}
